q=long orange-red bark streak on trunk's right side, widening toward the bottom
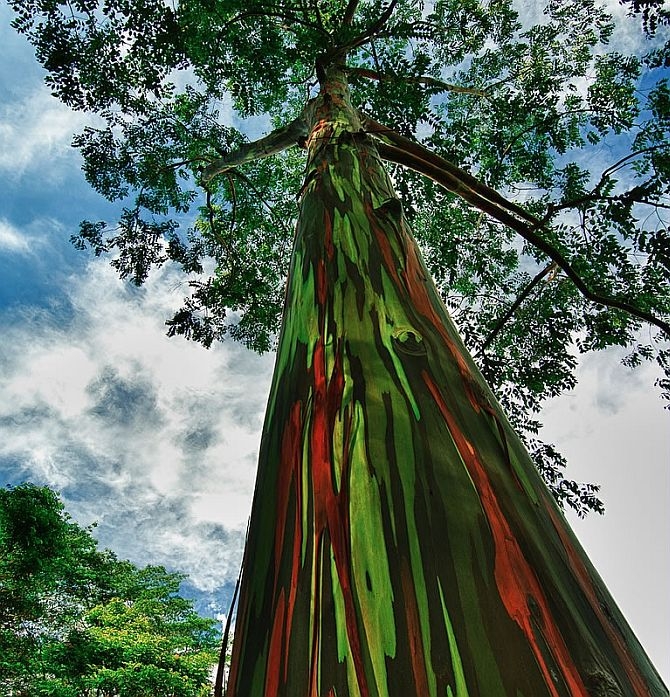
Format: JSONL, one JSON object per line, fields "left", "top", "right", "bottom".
{"left": 423, "top": 371, "right": 588, "bottom": 697}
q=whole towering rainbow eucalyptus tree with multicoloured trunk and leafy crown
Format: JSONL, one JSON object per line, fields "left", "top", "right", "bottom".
{"left": 13, "top": 0, "right": 670, "bottom": 697}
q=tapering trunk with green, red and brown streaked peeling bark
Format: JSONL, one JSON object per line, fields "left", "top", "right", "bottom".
{"left": 227, "top": 73, "right": 668, "bottom": 697}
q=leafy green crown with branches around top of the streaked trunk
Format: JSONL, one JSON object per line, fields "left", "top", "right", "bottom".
{"left": 11, "top": 0, "right": 670, "bottom": 513}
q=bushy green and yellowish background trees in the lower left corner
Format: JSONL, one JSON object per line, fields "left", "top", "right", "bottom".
{"left": 0, "top": 484, "right": 220, "bottom": 697}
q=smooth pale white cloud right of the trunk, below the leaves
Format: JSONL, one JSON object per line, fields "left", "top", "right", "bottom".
{"left": 543, "top": 349, "right": 670, "bottom": 679}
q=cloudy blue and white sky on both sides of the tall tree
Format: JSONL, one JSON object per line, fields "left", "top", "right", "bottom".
{"left": 0, "top": 4, "right": 670, "bottom": 684}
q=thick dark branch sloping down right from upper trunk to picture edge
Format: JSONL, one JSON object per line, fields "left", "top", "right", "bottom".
{"left": 365, "top": 119, "right": 670, "bottom": 337}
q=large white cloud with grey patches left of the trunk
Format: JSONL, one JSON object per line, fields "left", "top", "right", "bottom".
{"left": 0, "top": 253, "right": 272, "bottom": 588}
